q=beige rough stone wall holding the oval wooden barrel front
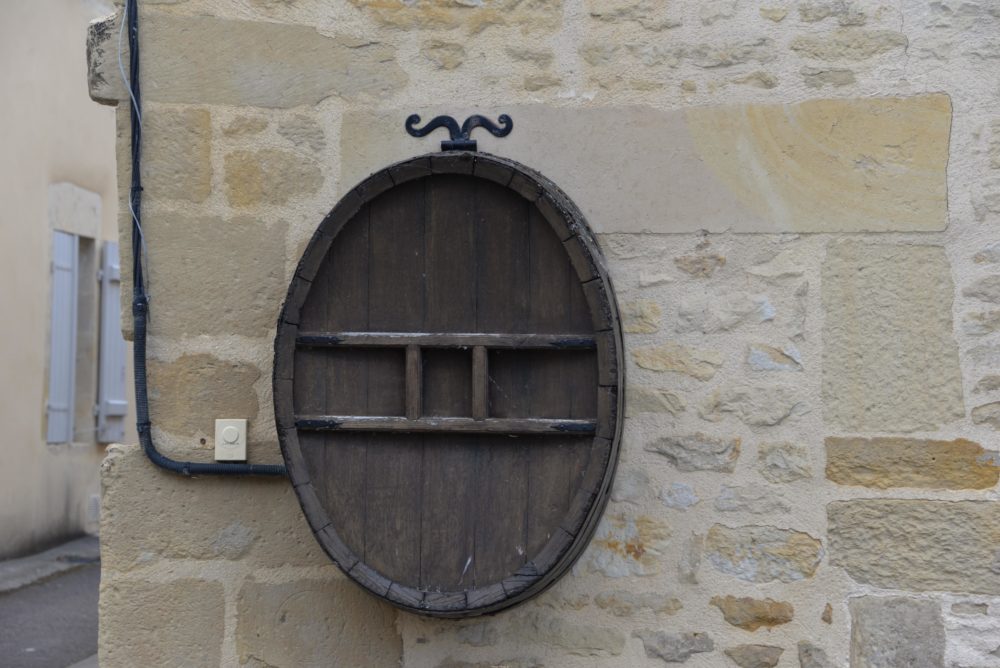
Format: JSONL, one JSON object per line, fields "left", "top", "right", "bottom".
{"left": 89, "top": 0, "right": 1000, "bottom": 668}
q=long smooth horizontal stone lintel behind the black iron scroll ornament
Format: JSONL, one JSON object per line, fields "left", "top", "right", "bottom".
{"left": 340, "top": 95, "right": 951, "bottom": 233}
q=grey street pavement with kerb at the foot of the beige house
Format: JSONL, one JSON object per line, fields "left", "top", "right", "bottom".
{"left": 0, "top": 539, "right": 101, "bottom": 668}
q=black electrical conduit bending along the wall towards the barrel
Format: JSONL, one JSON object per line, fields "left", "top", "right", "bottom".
{"left": 125, "top": 0, "right": 287, "bottom": 476}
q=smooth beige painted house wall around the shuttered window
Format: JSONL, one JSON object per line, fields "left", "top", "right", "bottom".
{"left": 0, "top": 0, "right": 135, "bottom": 558}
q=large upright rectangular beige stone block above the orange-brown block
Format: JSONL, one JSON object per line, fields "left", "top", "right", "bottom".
{"left": 822, "top": 241, "right": 965, "bottom": 432}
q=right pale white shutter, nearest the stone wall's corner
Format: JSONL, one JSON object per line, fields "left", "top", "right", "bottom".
{"left": 97, "top": 241, "right": 128, "bottom": 443}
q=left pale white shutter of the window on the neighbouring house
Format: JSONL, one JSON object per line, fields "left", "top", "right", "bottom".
{"left": 45, "top": 232, "right": 80, "bottom": 443}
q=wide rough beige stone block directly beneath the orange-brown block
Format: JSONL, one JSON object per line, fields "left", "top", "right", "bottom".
{"left": 827, "top": 499, "right": 1000, "bottom": 596}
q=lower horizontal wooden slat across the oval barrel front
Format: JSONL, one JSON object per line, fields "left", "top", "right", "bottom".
{"left": 295, "top": 415, "right": 597, "bottom": 435}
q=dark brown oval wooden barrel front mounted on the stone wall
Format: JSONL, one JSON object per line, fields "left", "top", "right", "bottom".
{"left": 274, "top": 152, "right": 624, "bottom": 617}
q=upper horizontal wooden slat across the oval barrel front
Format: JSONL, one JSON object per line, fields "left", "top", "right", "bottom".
{"left": 296, "top": 332, "right": 597, "bottom": 350}
